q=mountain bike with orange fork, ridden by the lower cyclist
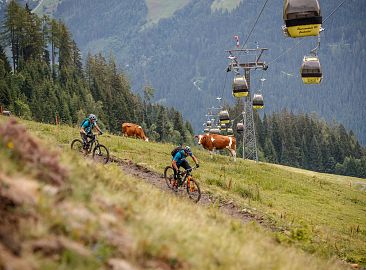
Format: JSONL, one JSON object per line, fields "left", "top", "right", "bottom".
{"left": 164, "top": 166, "right": 201, "bottom": 203}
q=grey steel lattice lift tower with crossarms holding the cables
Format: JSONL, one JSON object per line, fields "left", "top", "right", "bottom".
{"left": 226, "top": 47, "right": 268, "bottom": 162}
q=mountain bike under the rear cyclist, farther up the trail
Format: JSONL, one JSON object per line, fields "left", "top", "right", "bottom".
{"left": 71, "top": 134, "right": 109, "bottom": 164}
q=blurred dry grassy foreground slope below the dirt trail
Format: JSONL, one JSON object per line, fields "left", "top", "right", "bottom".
{"left": 0, "top": 117, "right": 352, "bottom": 269}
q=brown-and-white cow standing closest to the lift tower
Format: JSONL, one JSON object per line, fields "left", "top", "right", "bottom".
{"left": 196, "top": 134, "right": 236, "bottom": 160}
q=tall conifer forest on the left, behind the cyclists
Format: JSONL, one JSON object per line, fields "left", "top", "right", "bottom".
{"left": 0, "top": 1, "right": 193, "bottom": 146}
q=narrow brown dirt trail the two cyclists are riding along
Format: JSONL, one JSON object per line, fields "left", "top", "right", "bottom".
{"left": 110, "top": 156, "right": 280, "bottom": 231}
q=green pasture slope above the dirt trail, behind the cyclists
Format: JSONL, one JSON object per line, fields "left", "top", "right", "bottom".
{"left": 3, "top": 116, "right": 366, "bottom": 264}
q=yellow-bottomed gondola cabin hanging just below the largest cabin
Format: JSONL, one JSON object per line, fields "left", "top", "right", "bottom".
{"left": 300, "top": 56, "right": 323, "bottom": 84}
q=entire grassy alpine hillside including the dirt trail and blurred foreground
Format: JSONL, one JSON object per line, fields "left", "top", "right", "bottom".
{"left": 0, "top": 116, "right": 366, "bottom": 269}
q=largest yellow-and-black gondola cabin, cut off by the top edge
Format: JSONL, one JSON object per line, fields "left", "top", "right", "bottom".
{"left": 283, "top": 0, "right": 323, "bottom": 38}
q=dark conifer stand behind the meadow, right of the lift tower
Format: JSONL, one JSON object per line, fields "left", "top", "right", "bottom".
{"left": 250, "top": 110, "right": 366, "bottom": 177}
